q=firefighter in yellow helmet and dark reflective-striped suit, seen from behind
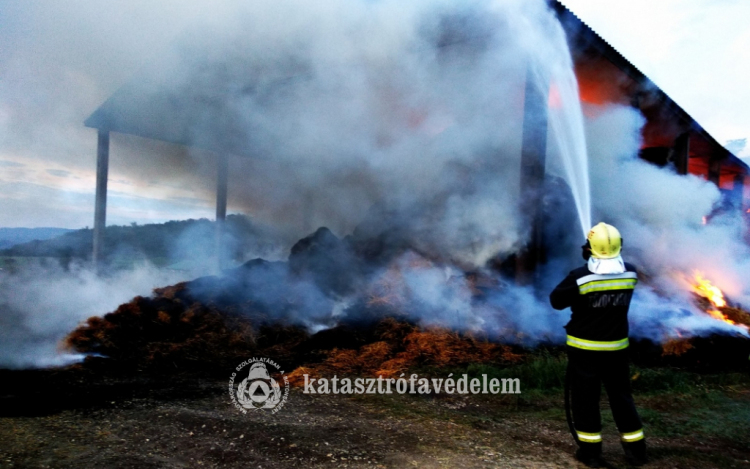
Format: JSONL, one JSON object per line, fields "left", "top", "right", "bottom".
{"left": 550, "top": 223, "right": 646, "bottom": 467}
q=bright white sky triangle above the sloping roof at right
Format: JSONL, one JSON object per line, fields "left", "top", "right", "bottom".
{"left": 562, "top": 0, "right": 750, "bottom": 158}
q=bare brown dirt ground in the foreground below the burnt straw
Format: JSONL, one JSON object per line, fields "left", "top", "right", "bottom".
{"left": 0, "top": 374, "right": 750, "bottom": 469}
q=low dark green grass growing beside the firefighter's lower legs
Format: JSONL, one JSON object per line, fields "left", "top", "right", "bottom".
{"left": 406, "top": 351, "right": 750, "bottom": 451}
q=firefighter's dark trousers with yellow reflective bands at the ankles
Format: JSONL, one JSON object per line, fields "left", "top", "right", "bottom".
{"left": 568, "top": 346, "right": 645, "bottom": 455}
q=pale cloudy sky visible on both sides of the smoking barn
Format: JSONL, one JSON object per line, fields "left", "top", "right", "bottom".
{"left": 0, "top": 0, "right": 750, "bottom": 228}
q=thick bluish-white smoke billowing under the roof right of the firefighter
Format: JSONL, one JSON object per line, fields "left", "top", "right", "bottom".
{"left": 587, "top": 106, "right": 750, "bottom": 340}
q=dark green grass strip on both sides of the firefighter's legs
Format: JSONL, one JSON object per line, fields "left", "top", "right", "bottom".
{"left": 352, "top": 350, "right": 750, "bottom": 468}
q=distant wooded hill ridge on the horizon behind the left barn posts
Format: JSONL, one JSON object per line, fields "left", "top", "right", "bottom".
{"left": 0, "top": 215, "right": 290, "bottom": 266}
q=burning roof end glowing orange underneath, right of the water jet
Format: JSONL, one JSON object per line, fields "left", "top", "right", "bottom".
{"left": 553, "top": 2, "right": 750, "bottom": 210}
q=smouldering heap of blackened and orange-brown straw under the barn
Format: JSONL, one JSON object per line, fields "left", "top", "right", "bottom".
{"left": 66, "top": 228, "right": 750, "bottom": 382}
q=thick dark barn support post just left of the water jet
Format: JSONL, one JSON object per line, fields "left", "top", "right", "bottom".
{"left": 516, "top": 69, "right": 549, "bottom": 285}
